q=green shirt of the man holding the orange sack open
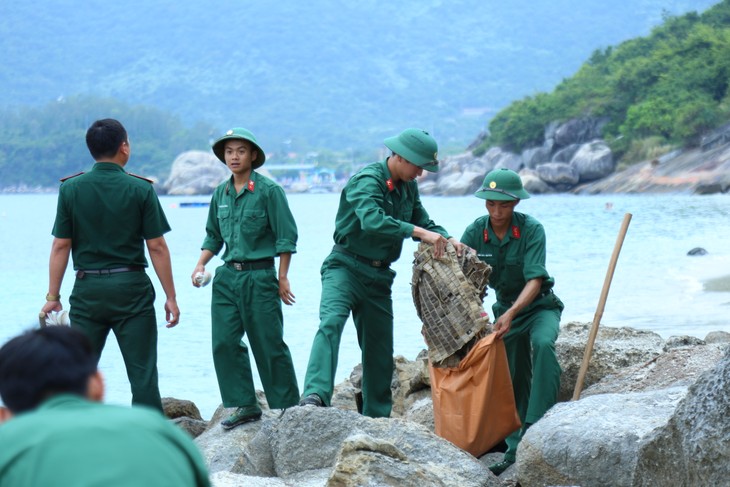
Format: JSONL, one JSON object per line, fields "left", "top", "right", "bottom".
{"left": 461, "top": 212, "right": 555, "bottom": 307}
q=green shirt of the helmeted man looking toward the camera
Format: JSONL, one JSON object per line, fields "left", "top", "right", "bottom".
{"left": 202, "top": 171, "right": 297, "bottom": 262}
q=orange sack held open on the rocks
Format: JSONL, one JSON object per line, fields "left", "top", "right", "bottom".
{"left": 429, "top": 333, "right": 521, "bottom": 457}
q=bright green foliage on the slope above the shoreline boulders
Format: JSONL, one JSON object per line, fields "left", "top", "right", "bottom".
{"left": 481, "top": 0, "right": 730, "bottom": 157}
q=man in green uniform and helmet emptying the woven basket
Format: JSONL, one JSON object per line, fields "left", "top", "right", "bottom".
{"left": 300, "top": 129, "right": 462, "bottom": 417}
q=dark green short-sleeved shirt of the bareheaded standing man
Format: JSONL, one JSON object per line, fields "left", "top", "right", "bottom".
{"left": 52, "top": 162, "right": 170, "bottom": 270}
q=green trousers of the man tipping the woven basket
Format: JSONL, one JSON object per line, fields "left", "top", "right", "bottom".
{"left": 304, "top": 252, "right": 395, "bottom": 418}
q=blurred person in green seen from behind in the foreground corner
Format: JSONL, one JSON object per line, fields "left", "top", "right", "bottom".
{"left": 0, "top": 326, "right": 210, "bottom": 487}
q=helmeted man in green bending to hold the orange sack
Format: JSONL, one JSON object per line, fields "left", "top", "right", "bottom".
{"left": 461, "top": 169, "right": 563, "bottom": 475}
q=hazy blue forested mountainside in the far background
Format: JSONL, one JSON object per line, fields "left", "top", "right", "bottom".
{"left": 0, "top": 0, "right": 714, "bottom": 185}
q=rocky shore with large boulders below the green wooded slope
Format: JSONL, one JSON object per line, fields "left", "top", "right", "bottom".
{"left": 419, "top": 118, "right": 730, "bottom": 196}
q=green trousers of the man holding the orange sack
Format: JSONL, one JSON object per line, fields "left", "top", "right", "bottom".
{"left": 492, "top": 293, "right": 563, "bottom": 461}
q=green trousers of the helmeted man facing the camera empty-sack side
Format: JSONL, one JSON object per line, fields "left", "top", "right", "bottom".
{"left": 211, "top": 265, "right": 299, "bottom": 409}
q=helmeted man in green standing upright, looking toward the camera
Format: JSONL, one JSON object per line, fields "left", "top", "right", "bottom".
{"left": 192, "top": 128, "right": 299, "bottom": 429}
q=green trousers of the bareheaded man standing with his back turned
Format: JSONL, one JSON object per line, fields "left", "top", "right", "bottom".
{"left": 69, "top": 272, "right": 162, "bottom": 411}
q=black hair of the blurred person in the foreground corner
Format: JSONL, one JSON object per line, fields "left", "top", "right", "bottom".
{"left": 0, "top": 326, "right": 98, "bottom": 414}
